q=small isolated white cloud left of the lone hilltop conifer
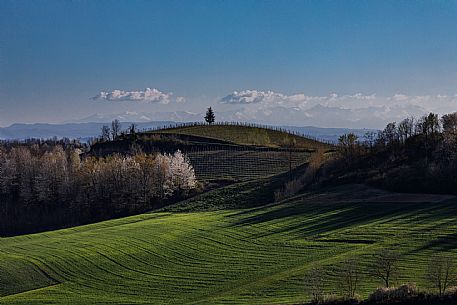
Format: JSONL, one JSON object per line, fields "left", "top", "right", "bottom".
{"left": 92, "top": 88, "right": 173, "bottom": 104}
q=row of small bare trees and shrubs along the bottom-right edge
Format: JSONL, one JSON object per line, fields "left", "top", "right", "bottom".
{"left": 305, "top": 249, "right": 457, "bottom": 304}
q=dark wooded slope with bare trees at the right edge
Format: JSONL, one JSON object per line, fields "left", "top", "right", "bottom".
{"left": 332, "top": 113, "right": 457, "bottom": 194}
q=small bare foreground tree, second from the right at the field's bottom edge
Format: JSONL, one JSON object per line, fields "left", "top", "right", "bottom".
{"left": 371, "top": 249, "right": 400, "bottom": 288}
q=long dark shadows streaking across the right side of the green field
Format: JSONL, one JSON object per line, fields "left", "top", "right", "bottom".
{"left": 228, "top": 186, "right": 457, "bottom": 241}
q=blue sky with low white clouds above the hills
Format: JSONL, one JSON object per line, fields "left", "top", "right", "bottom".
{"left": 0, "top": 0, "right": 457, "bottom": 128}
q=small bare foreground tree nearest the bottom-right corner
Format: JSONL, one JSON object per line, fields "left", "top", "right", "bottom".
{"left": 426, "top": 255, "right": 456, "bottom": 295}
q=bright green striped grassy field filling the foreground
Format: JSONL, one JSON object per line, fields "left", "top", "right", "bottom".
{"left": 0, "top": 186, "right": 457, "bottom": 304}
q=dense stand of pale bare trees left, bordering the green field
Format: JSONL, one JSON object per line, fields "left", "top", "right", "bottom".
{"left": 0, "top": 143, "right": 199, "bottom": 235}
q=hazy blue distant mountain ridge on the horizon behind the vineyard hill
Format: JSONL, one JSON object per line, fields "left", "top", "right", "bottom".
{"left": 0, "top": 116, "right": 373, "bottom": 142}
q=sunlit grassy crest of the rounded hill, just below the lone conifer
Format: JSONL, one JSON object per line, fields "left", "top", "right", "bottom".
{"left": 154, "top": 124, "right": 329, "bottom": 149}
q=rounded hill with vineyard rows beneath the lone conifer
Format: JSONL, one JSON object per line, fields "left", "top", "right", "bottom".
{"left": 91, "top": 124, "right": 332, "bottom": 181}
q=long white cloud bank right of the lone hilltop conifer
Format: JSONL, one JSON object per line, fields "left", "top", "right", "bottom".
{"left": 220, "top": 90, "right": 457, "bottom": 128}
